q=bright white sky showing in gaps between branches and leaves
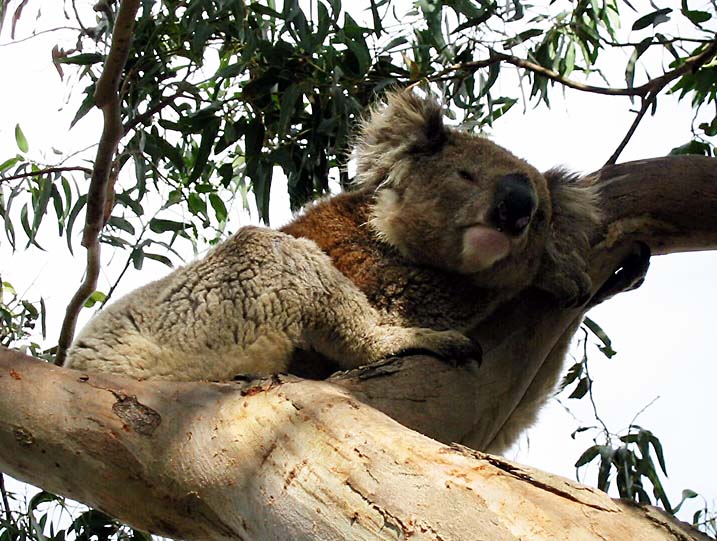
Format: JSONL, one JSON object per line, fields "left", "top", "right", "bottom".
{"left": 0, "top": 2, "right": 717, "bottom": 520}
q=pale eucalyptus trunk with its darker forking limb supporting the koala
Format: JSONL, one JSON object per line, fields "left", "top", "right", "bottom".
{"left": 0, "top": 157, "right": 717, "bottom": 540}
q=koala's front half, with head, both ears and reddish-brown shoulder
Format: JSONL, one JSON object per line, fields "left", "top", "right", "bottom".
{"left": 282, "top": 91, "right": 599, "bottom": 332}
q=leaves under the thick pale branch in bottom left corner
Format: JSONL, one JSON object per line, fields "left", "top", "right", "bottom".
{"left": 0, "top": 491, "right": 152, "bottom": 541}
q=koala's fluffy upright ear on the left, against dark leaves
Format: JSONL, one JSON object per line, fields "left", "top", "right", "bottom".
{"left": 354, "top": 90, "right": 448, "bottom": 189}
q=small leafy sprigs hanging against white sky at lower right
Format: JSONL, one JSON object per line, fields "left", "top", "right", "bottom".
{"left": 560, "top": 318, "right": 714, "bottom": 533}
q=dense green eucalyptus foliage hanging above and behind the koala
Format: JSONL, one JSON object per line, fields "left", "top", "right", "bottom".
{"left": 0, "top": 0, "right": 717, "bottom": 268}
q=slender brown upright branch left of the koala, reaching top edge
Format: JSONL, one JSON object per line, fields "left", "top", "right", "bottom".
{"left": 55, "top": 0, "right": 140, "bottom": 365}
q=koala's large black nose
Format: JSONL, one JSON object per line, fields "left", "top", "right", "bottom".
{"left": 492, "top": 173, "right": 538, "bottom": 235}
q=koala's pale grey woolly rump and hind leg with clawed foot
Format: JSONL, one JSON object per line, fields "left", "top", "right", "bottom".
{"left": 65, "top": 227, "right": 480, "bottom": 380}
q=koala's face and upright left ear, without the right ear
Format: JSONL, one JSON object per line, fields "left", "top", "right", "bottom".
{"left": 355, "top": 91, "right": 551, "bottom": 287}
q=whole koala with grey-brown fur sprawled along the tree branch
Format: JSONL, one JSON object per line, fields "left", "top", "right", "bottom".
{"left": 65, "top": 91, "right": 597, "bottom": 400}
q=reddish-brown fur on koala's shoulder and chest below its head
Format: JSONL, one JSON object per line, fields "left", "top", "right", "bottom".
{"left": 282, "top": 192, "right": 494, "bottom": 329}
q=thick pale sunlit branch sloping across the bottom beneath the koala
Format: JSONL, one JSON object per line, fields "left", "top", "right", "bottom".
{"left": 0, "top": 349, "right": 706, "bottom": 541}
